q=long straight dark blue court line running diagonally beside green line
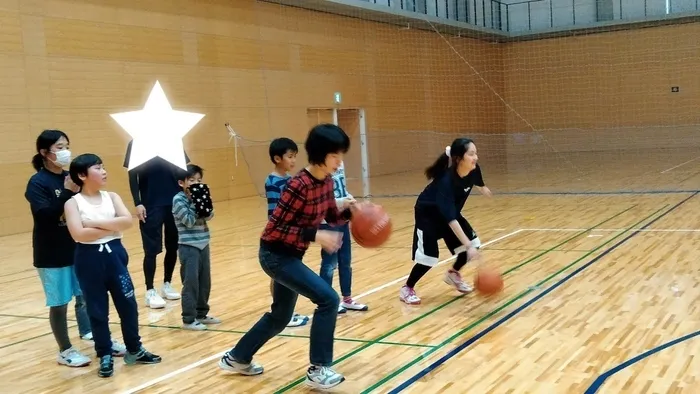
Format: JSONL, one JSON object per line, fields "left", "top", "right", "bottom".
{"left": 389, "top": 192, "right": 699, "bottom": 394}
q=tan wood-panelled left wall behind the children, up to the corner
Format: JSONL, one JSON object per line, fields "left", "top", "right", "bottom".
{"left": 0, "top": 0, "right": 505, "bottom": 235}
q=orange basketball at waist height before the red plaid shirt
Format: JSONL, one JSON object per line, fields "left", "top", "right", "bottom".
{"left": 350, "top": 202, "right": 391, "bottom": 248}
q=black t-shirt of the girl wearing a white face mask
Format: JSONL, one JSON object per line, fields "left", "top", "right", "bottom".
{"left": 24, "top": 169, "right": 75, "bottom": 268}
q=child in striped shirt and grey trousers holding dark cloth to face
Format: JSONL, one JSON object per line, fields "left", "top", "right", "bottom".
{"left": 173, "top": 164, "right": 221, "bottom": 331}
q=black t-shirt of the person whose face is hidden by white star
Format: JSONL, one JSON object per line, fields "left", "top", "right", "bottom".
{"left": 124, "top": 141, "right": 190, "bottom": 209}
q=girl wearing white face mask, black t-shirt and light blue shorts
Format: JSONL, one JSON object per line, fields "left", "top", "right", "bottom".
{"left": 24, "top": 130, "right": 126, "bottom": 367}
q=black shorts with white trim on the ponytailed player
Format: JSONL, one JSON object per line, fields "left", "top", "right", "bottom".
{"left": 412, "top": 210, "right": 477, "bottom": 267}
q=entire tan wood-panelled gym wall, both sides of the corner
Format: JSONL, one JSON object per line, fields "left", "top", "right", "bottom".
{"left": 0, "top": 0, "right": 700, "bottom": 235}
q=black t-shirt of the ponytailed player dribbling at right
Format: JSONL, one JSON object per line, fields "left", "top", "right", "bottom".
{"left": 416, "top": 164, "right": 484, "bottom": 223}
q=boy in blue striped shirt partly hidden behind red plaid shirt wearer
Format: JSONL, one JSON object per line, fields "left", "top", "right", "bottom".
{"left": 265, "top": 137, "right": 309, "bottom": 327}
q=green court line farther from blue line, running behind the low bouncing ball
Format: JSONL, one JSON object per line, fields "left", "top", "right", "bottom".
{"left": 275, "top": 204, "right": 637, "bottom": 394}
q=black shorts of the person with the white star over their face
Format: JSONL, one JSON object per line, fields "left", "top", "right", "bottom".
{"left": 139, "top": 206, "right": 178, "bottom": 256}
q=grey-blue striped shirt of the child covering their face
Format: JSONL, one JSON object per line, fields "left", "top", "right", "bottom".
{"left": 173, "top": 192, "right": 214, "bottom": 249}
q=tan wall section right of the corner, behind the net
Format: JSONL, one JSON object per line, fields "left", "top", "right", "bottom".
{"left": 503, "top": 23, "right": 700, "bottom": 153}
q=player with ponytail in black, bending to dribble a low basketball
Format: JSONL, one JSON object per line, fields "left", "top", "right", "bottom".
{"left": 399, "top": 138, "right": 491, "bottom": 305}
